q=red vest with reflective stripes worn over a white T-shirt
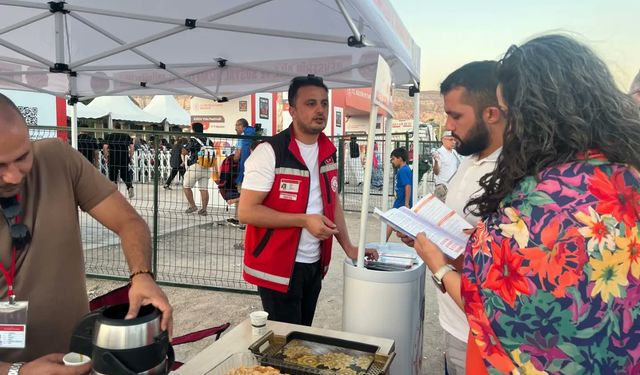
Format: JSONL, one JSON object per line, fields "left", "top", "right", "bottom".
{"left": 242, "top": 126, "right": 338, "bottom": 293}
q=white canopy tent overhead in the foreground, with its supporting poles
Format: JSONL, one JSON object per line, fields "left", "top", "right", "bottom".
{"left": 0, "top": 0, "right": 420, "bottom": 201}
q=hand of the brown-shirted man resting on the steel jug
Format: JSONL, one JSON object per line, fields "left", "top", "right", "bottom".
{"left": 125, "top": 273, "right": 173, "bottom": 337}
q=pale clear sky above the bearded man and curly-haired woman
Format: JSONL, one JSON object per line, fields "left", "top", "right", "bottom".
{"left": 389, "top": 0, "right": 640, "bottom": 92}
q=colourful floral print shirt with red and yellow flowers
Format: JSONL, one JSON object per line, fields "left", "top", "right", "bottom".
{"left": 462, "top": 153, "right": 640, "bottom": 374}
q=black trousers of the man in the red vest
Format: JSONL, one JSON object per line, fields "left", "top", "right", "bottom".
{"left": 258, "top": 261, "right": 322, "bottom": 326}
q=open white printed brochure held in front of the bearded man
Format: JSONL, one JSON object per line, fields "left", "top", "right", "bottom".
{"left": 374, "top": 194, "right": 473, "bottom": 259}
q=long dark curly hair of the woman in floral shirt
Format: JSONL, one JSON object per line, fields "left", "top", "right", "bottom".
{"left": 466, "top": 35, "right": 640, "bottom": 216}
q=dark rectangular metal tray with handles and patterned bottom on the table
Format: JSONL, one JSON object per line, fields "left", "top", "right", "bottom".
{"left": 249, "top": 331, "right": 395, "bottom": 375}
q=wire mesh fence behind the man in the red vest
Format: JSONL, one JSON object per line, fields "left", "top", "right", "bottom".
{"left": 30, "top": 126, "right": 435, "bottom": 292}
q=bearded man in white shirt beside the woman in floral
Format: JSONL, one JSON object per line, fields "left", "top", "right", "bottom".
{"left": 398, "top": 61, "right": 506, "bottom": 375}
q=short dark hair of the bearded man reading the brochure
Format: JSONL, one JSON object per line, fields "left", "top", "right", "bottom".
{"left": 440, "top": 60, "right": 499, "bottom": 113}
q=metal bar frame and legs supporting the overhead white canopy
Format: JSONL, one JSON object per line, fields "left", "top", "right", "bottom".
{"left": 0, "top": 0, "right": 419, "bottom": 153}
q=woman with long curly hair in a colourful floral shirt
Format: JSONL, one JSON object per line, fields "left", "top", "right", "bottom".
{"left": 415, "top": 35, "right": 640, "bottom": 374}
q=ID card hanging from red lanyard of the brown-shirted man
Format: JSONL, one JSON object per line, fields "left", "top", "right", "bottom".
{"left": 0, "top": 301, "right": 29, "bottom": 349}
